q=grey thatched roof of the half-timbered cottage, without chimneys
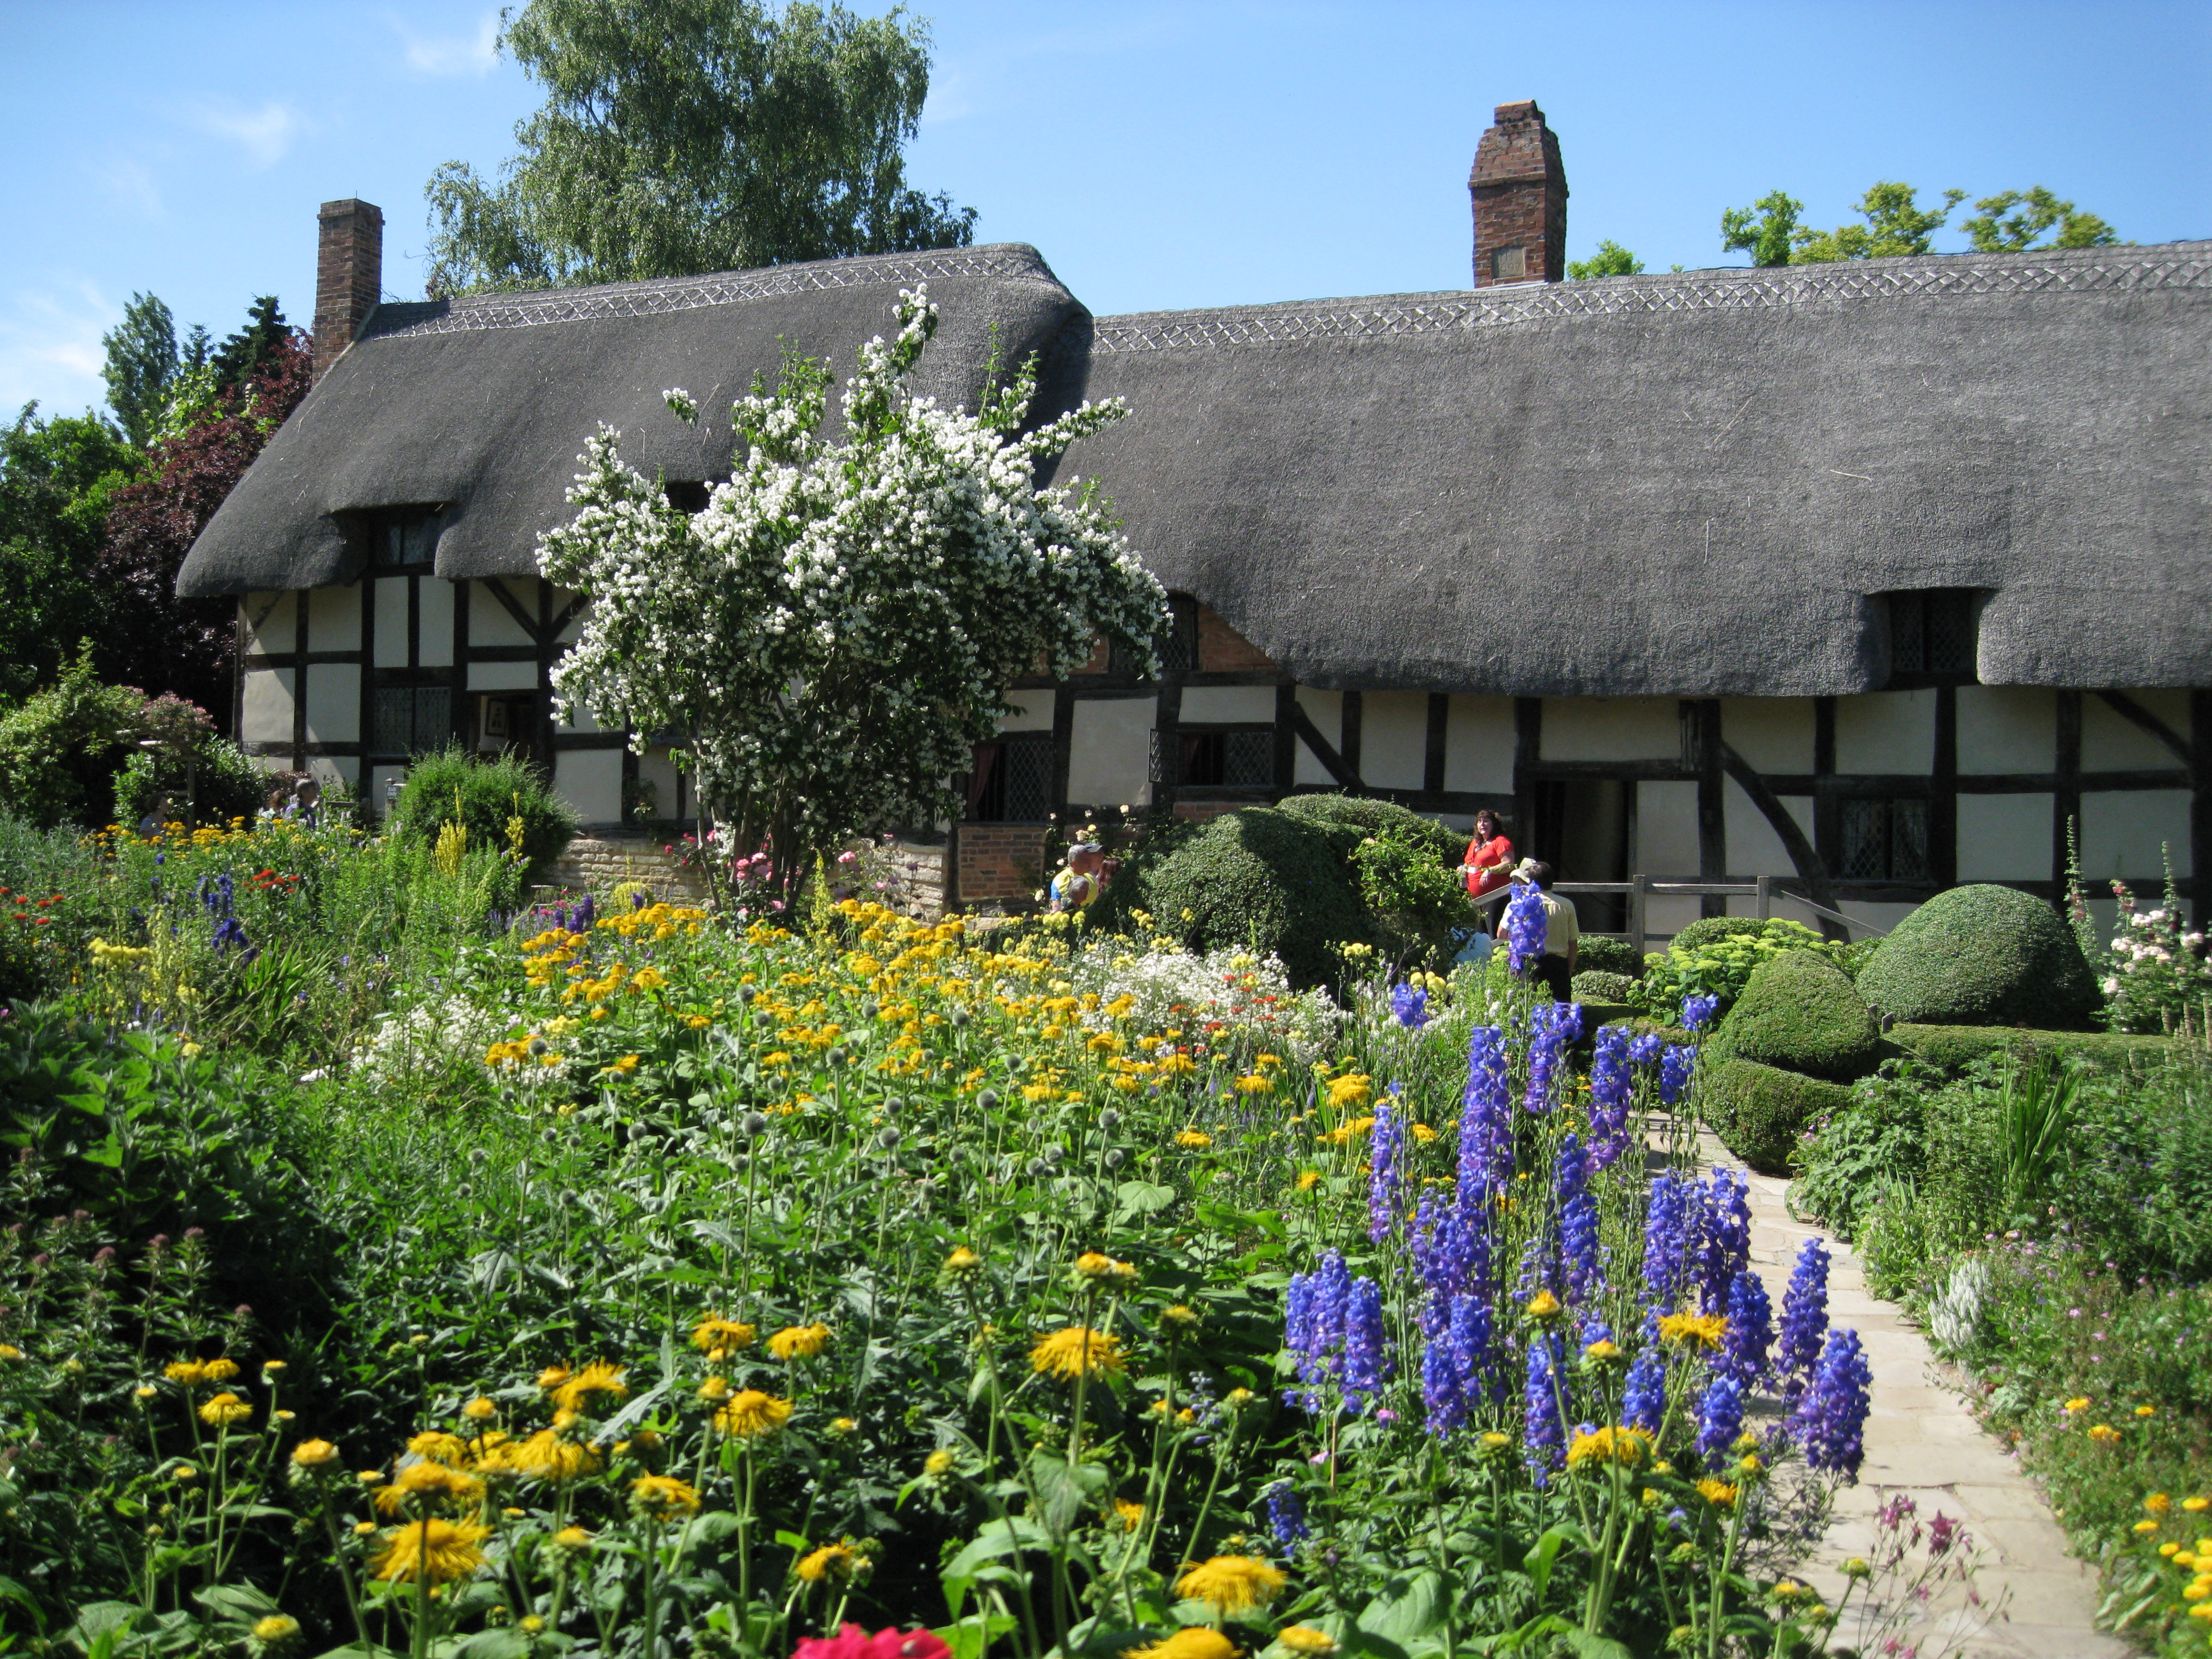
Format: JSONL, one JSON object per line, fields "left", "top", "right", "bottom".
{"left": 179, "top": 243, "right": 2212, "bottom": 695}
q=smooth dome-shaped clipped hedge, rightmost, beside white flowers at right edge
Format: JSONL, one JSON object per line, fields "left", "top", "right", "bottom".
{"left": 1858, "top": 885, "right": 2099, "bottom": 1029}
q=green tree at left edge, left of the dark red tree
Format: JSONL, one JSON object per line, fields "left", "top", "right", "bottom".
{"left": 0, "top": 416, "right": 137, "bottom": 701}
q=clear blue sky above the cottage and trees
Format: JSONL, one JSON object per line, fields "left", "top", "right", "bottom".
{"left": 0, "top": 0, "right": 2212, "bottom": 418}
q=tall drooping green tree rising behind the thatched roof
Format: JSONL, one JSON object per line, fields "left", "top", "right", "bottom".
{"left": 425, "top": 0, "right": 975, "bottom": 294}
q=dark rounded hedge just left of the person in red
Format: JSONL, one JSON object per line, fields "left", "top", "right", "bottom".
{"left": 1093, "top": 807, "right": 1376, "bottom": 987}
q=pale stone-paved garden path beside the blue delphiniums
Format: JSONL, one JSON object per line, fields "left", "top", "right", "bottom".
{"left": 1699, "top": 1133, "right": 2135, "bottom": 1659}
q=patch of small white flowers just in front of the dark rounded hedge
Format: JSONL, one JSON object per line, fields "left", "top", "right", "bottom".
{"left": 1068, "top": 938, "right": 1338, "bottom": 1064}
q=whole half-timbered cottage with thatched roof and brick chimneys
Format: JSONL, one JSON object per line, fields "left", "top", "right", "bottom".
{"left": 179, "top": 104, "right": 2212, "bottom": 931}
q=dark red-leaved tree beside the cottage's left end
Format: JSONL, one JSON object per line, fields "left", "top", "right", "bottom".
{"left": 95, "top": 330, "right": 314, "bottom": 723}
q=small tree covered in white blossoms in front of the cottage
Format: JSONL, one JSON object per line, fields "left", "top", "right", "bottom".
{"left": 538, "top": 288, "right": 1166, "bottom": 894}
